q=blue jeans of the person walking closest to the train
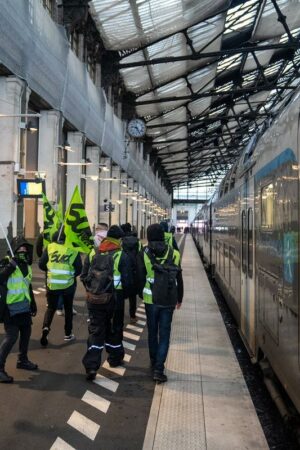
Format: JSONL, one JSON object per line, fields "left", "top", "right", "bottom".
{"left": 145, "top": 303, "right": 175, "bottom": 373}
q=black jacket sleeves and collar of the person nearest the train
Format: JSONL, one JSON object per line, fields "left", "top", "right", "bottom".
{"left": 137, "top": 241, "right": 183, "bottom": 303}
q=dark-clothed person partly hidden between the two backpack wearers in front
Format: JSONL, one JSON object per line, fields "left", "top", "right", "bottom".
{"left": 121, "top": 223, "right": 142, "bottom": 323}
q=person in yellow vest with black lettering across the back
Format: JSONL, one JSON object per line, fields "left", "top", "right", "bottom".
{"left": 39, "top": 231, "right": 82, "bottom": 347}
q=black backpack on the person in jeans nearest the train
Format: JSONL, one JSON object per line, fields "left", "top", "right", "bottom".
{"left": 145, "top": 247, "right": 181, "bottom": 307}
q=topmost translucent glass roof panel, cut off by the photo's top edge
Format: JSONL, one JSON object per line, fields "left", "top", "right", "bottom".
{"left": 89, "top": 0, "right": 229, "bottom": 50}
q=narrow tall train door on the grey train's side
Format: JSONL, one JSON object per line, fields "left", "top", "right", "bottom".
{"left": 240, "top": 178, "right": 255, "bottom": 354}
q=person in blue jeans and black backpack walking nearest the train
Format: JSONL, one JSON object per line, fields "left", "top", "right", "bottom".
{"left": 137, "top": 224, "right": 183, "bottom": 383}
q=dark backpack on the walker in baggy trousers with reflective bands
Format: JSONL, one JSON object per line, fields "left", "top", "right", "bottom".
{"left": 84, "top": 252, "right": 115, "bottom": 304}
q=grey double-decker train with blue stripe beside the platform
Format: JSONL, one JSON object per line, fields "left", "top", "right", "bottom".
{"left": 194, "top": 88, "right": 300, "bottom": 412}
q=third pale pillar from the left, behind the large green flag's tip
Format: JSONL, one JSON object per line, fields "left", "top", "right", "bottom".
{"left": 66, "top": 131, "right": 83, "bottom": 207}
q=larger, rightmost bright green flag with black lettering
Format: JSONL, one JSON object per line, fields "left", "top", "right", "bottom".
{"left": 64, "top": 186, "right": 93, "bottom": 253}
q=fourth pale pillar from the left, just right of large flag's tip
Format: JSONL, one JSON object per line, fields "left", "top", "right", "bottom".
{"left": 85, "top": 146, "right": 100, "bottom": 231}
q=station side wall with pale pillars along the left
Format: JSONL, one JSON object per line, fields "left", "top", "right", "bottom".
{"left": 0, "top": 0, "right": 171, "bottom": 250}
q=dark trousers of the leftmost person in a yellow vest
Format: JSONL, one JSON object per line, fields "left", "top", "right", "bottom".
{"left": 0, "top": 314, "right": 31, "bottom": 370}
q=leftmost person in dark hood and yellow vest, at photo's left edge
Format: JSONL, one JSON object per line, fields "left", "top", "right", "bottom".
{"left": 0, "top": 237, "right": 38, "bottom": 383}
